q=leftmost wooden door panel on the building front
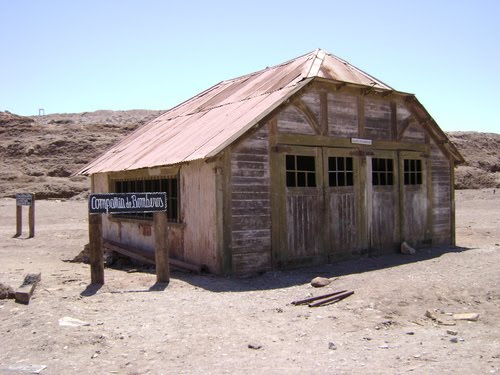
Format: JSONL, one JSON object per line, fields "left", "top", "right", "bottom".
{"left": 279, "top": 147, "right": 324, "bottom": 266}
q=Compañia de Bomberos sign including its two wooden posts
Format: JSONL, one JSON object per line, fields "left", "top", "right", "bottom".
{"left": 89, "top": 192, "right": 170, "bottom": 284}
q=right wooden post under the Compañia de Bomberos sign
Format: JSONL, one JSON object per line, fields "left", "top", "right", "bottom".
{"left": 153, "top": 212, "right": 170, "bottom": 283}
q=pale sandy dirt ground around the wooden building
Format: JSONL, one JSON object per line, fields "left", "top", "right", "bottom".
{"left": 0, "top": 189, "right": 500, "bottom": 375}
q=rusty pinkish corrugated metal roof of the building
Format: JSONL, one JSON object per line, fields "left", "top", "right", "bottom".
{"left": 78, "top": 49, "right": 392, "bottom": 174}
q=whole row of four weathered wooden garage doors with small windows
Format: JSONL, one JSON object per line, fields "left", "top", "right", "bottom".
{"left": 273, "top": 147, "right": 428, "bottom": 266}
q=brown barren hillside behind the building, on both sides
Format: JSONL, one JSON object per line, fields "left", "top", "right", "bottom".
{"left": 0, "top": 110, "right": 500, "bottom": 199}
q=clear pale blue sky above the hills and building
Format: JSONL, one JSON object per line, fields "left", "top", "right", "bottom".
{"left": 0, "top": 0, "right": 500, "bottom": 133}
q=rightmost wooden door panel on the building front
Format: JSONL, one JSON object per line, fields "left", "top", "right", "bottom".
{"left": 399, "top": 152, "right": 428, "bottom": 247}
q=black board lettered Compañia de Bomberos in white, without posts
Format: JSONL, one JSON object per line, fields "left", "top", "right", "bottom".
{"left": 89, "top": 192, "right": 167, "bottom": 214}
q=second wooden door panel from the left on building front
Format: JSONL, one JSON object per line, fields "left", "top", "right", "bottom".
{"left": 323, "top": 148, "right": 362, "bottom": 258}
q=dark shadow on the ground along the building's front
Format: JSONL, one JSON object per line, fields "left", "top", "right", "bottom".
{"left": 172, "top": 247, "right": 472, "bottom": 292}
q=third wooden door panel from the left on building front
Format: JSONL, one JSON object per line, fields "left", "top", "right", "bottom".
{"left": 366, "top": 151, "right": 399, "bottom": 253}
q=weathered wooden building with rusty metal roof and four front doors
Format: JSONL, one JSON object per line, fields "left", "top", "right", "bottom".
{"left": 79, "top": 49, "right": 463, "bottom": 274}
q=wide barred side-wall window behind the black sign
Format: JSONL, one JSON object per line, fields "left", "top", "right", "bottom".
{"left": 113, "top": 176, "right": 179, "bottom": 223}
